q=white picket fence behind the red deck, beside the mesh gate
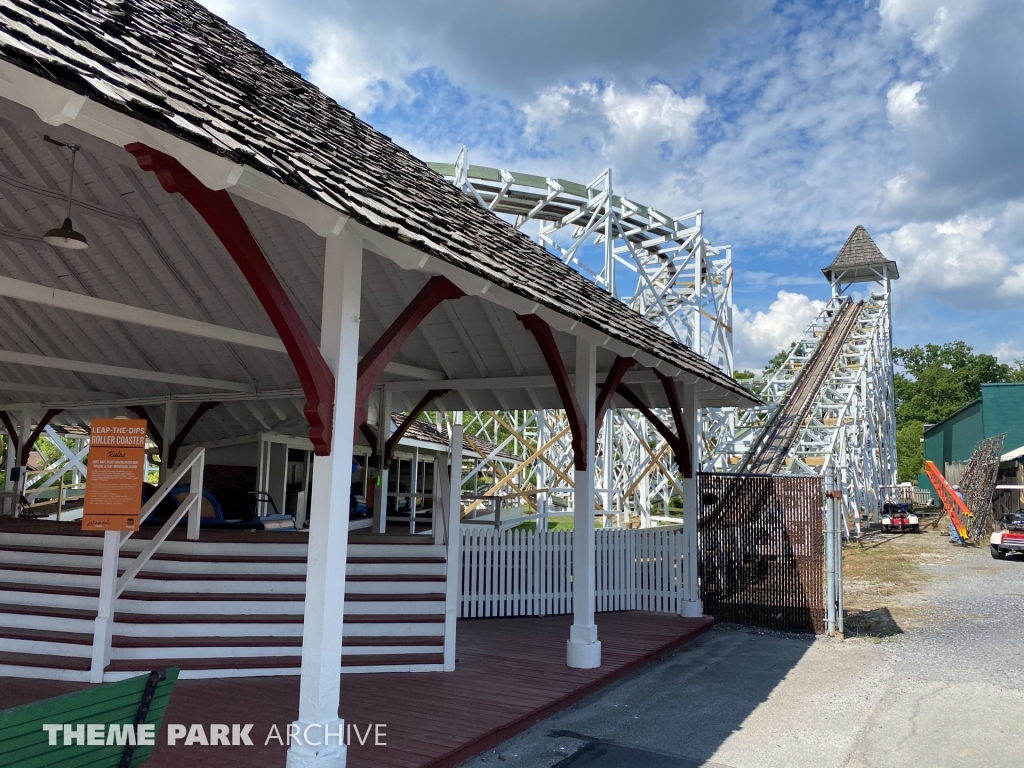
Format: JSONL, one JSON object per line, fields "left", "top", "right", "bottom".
{"left": 459, "top": 528, "right": 683, "bottom": 618}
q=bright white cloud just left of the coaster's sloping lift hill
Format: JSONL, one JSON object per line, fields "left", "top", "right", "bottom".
{"left": 733, "top": 291, "right": 825, "bottom": 370}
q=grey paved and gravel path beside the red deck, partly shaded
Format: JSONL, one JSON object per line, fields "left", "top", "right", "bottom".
{"left": 465, "top": 535, "right": 1024, "bottom": 768}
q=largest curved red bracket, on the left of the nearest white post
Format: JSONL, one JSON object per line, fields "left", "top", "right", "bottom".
{"left": 125, "top": 143, "right": 335, "bottom": 456}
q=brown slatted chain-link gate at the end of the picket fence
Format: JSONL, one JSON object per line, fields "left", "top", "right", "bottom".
{"left": 697, "top": 473, "right": 825, "bottom": 634}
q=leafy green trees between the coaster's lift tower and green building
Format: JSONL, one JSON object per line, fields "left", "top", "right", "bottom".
{"left": 893, "top": 341, "right": 1007, "bottom": 427}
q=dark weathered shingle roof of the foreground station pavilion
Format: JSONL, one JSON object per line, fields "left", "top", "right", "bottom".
{"left": 0, "top": 0, "right": 751, "bottom": 401}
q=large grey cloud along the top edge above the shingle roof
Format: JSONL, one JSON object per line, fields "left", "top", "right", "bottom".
{"left": 202, "top": 0, "right": 770, "bottom": 103}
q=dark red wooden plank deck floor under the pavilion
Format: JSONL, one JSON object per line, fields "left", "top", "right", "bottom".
{"left": 0, "top": 611, "right": 711, "bottom": 768}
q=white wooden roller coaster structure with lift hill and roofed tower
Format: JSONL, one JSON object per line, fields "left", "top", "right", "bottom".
{"left": 430, "top": 147, "right": 898, "bottom": 529}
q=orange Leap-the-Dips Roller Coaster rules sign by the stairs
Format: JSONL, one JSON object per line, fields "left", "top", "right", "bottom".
{"left": 82, "top": 419, "right": 145, "bottom": 530}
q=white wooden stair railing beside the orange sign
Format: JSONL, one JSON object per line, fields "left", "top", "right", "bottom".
{"left": 89, "top": 447, "right": 206, "bottom": 683}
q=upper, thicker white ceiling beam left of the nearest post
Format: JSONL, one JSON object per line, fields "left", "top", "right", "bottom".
{"left": 0, "top": 276, "right": 285, "bottom": 352}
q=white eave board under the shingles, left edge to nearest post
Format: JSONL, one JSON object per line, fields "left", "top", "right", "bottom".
{"left": 0, "top": 61, "right": 349, "bottom": 238}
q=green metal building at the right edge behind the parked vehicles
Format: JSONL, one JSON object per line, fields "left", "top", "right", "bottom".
{"left": 919, "top": 383, "right": 1024, "bottom": 495}
